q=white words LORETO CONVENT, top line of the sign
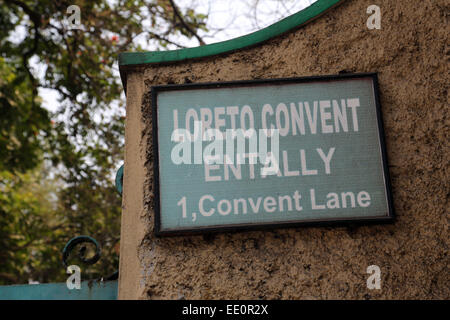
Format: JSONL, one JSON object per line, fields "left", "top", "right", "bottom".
{"left": 173, "top": 98, "right": 360, "bottom": 140}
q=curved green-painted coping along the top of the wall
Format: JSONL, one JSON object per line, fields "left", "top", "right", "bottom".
{"left": 119, "top": 0, "right": 343, "bottom": 67}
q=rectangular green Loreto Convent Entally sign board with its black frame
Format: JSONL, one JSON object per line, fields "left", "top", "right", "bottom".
{"left": 151, "top": 74, "right": 393, "bottom": 235}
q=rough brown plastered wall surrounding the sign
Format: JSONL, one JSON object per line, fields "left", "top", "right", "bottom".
{"left": 119, "top": 0, "right": 450, "bottom": 299}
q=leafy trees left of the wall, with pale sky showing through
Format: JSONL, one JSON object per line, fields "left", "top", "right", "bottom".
{"left": 0, "top": 0, "right": 207, "bottom": 284}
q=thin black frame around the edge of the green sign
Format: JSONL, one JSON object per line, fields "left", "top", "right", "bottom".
{"left": 150, "top": 73, "right": 395, "bottom": 237}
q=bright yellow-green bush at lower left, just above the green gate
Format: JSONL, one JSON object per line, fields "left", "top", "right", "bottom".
{"left": 0, "top": 166, "right": 69, "bottom": 283}
